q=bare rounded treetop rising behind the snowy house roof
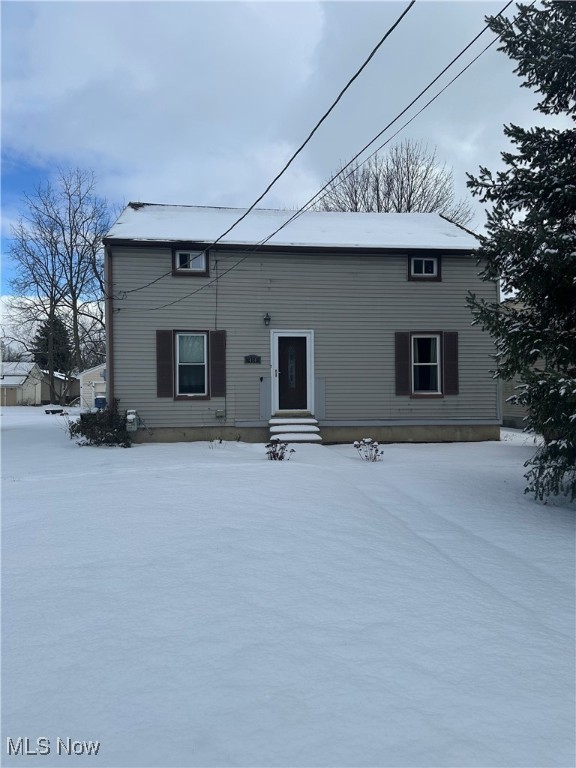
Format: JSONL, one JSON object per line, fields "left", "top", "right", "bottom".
{"left": 315, "top": 140, "right": 472, "bottom": 225}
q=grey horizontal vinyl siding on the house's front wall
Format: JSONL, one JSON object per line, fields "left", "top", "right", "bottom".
{"left": 112, "top": 247, "right": 498, "bottom": 427}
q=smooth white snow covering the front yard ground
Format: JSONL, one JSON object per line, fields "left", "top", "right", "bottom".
{"left": 1, "top": 408, "right": 575, "bottom": 768}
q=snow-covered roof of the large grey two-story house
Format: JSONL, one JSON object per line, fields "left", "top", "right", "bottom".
{"left": 105, "top": 203, "right": 478, "bottom": 251}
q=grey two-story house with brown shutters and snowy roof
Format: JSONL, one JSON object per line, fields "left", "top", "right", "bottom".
{"left": 104, "top": 203, "right": 500, "bottom": 442}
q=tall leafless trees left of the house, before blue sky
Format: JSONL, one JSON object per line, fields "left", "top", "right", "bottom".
{"left": 9, "top": 169, "right": 110, "bottom": 379}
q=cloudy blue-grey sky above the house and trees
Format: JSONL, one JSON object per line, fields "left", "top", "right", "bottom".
{"left": 1, "top": 0, "right": 560, "bottom": 290}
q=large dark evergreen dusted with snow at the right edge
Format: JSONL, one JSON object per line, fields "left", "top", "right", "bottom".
{"left": 468, "top": 0, "right": 576, "bottom": 499}
